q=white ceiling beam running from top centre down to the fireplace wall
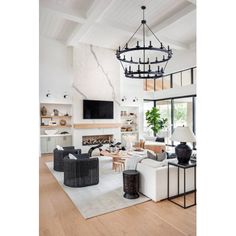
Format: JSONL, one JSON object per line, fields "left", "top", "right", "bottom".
{"left": 66, "top": 0, "right": 114, "bottom": 46}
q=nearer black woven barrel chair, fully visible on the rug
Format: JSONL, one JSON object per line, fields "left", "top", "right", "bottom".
{"left": 64, "top": 153, "right": 99, "bottom": 187}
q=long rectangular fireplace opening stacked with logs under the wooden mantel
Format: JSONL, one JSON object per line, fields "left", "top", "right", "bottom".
{"left": 82, "top": 134, "right": 113, "bottom": 146}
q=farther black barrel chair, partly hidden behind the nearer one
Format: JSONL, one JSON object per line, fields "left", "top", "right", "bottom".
{"left": 53, "top": 146, "right": 81, "bottom": 172}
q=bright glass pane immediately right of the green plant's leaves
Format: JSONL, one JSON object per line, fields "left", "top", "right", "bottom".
{"left": 156, "top": 100, "right": 171, "bottom": 144}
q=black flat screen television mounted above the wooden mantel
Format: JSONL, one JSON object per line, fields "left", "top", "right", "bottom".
{"left": 83, "top": 100, "right": 114, "bottom": 119}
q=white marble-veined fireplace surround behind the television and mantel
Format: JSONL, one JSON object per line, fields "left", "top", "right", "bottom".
{"left": 72, "top": 44, "right": 120, "bottom": 152}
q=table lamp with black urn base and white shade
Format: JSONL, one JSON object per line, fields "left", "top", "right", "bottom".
{"left": 170, "top": 126, "right": 196, "bottom": 164}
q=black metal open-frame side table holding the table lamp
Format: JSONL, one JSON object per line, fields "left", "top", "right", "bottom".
{"left": 167, "top": 162, "right": 197, "bottom": 209}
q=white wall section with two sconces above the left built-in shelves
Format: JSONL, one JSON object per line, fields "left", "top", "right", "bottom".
{"left": 39, "top": 36, "right": 73, "bottom": 103}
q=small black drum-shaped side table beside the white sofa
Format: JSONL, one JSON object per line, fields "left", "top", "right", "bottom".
{"left": 123, "top": 170, "right": 139, "bottom": 199}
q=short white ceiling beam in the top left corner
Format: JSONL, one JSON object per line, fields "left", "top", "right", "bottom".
{"left": 40, "top": 2, "right": 86, "bottom": 24}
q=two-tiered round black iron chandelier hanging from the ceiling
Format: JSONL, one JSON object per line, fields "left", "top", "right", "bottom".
{"left": 116, "top": 6, "right": 172, "bottom": 79}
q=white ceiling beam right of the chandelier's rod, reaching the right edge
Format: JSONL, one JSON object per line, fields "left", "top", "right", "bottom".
{"left": 148, "top": 4, "right": 196, "bottom": 35}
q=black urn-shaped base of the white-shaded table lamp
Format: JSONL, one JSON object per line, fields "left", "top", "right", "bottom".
{"left": 175, "top": 142, "right": 192, "bottom": 165}
